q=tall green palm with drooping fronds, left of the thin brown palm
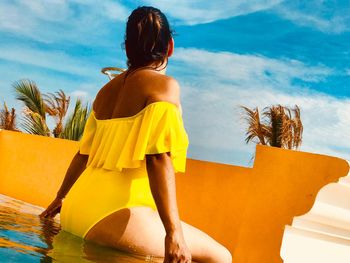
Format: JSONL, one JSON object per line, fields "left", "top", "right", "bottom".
{"left": 13, "top": 79, "right": 50, "bottom": 136}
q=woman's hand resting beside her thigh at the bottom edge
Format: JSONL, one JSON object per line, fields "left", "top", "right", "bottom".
{"left": 164, "top": 232, "right": 192, "bottom": 263}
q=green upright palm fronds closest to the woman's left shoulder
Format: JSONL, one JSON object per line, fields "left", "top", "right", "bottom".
{"left": 60, "top": 99, "right": 91, "bottom": 141}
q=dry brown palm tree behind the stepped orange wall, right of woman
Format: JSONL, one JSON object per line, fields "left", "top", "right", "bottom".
{"left": 241, "top": 105, "right": 303, "bottom": 149}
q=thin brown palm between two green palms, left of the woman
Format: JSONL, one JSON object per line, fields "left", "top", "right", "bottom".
{"left": 43, "top": 89, "right": 70, "bottom": 138}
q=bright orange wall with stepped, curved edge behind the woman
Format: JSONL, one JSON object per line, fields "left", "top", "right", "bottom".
{"left": 0, "top": 130, "right": 349, "bottom": 263}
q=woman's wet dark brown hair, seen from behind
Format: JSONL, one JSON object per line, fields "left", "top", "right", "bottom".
{"left": 125, "top": 6, "right": 172, "bottom": 70}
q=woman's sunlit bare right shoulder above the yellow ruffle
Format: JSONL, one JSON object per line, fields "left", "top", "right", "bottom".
{"left": 149, "top": 75, "right": 180, "bottom": 107}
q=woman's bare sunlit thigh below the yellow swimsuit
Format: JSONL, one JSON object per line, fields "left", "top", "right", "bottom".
{"left": 85, "top": 207, "right": 231, "bottom": 263}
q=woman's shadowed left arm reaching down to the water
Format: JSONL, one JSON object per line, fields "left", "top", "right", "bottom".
{"left": 39, "top": 152, "right": 89, "bottom": 218}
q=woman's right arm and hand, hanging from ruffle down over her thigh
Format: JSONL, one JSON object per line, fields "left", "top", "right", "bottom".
{"left": 146, "top": 153, "right": 191, "bottom": 262}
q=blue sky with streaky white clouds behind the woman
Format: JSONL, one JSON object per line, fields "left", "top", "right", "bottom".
{"left": 0, "top": 0, "right": 350, "bottom": 166}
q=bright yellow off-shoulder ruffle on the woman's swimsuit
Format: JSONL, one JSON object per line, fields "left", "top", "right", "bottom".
{"left": 79, "top": 101, "right": 189, "bottom": 172}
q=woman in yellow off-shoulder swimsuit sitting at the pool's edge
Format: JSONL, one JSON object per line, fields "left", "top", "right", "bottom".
{"left": 40, "top": 7, "right": 231, "bottom": 263}
